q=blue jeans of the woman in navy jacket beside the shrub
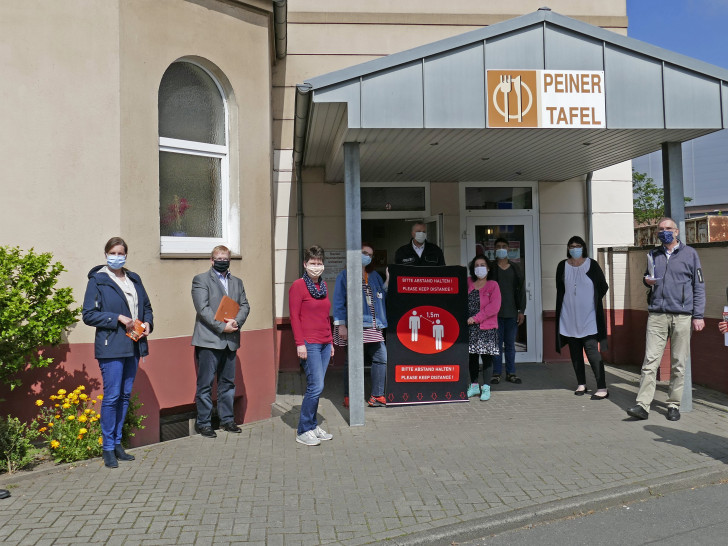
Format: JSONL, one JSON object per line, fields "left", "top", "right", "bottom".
{"left": 99, "top": 356, "right": 139, "bottom": 451}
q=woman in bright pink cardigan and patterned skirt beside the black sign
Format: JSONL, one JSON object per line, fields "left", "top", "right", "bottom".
{"left": 467, "top": 254, "right": 501, "bottom": 401}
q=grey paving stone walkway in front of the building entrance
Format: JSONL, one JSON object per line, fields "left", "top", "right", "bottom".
{"left": 0, "top": 364, "right": 728, "bottom": 545}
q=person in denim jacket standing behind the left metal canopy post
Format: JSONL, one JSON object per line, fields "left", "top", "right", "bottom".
{"left": 334, "top": 243, "right": 389, "bottom": 407}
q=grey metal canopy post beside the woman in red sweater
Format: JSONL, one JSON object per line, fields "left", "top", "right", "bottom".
{"left": 344, "top": 142, "right": 364, "bottom": 427}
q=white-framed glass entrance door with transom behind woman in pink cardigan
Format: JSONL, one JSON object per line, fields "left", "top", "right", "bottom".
{"left": 466, "top": 215, "right": 542, "bottom": 362}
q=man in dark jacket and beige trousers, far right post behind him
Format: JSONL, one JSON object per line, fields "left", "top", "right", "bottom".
{"left": 627, "top": 218, "right": 705, "bottom": 421}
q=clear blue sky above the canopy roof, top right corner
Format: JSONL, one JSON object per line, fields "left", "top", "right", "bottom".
{"left": 627, "top": 0, "right": 728, "bottom": 69}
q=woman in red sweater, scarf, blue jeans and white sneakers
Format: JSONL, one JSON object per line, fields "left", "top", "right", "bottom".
{"left": 288, "top": 245, "right": 334, "bottom": 446}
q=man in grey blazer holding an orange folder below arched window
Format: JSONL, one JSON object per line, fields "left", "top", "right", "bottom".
{"left": 192, "top": 245, "right": 250, "bottom": 438}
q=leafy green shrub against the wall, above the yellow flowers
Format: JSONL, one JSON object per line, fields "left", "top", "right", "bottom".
{"left": 0, "top": 246, "right": 80, "bottom": 390}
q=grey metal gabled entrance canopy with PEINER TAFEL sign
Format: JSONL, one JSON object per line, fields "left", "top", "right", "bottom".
{"left": 294, "top": 9, "right": 728, "bottom": 182}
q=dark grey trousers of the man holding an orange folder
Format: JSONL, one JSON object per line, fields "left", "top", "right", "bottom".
{"left": 195, "top": 347, "right": 235, "bottom": 428}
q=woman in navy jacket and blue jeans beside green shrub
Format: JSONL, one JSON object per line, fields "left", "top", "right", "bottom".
{"left": 83, "top": 237, "right": 154, "bottom": 468}
